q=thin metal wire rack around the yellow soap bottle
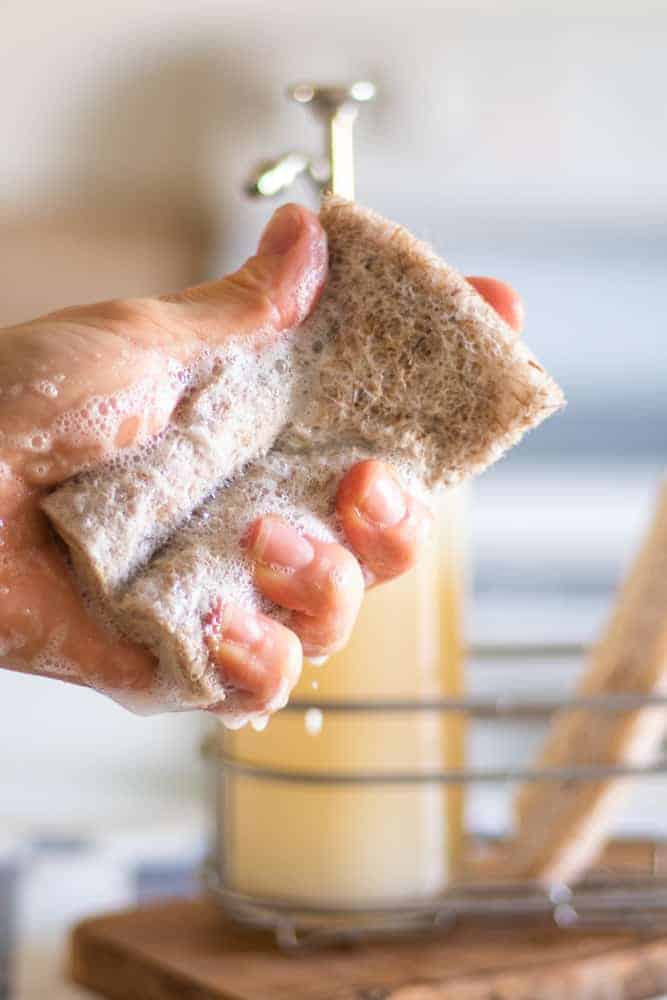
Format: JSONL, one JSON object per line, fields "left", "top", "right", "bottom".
{"left": 204, "top": 643, "right": 667, "bottom": 948}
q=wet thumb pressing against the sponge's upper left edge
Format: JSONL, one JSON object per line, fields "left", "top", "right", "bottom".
{"left": 164, "top": 205, "right": 327, "bottom": 344}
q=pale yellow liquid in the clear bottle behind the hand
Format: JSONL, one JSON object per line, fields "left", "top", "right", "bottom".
{"left": 219, "top": 491, "right": 464, "bottom": 905}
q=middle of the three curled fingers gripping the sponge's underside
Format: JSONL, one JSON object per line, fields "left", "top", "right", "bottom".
{"left": 247, "top": 517, "right": 364, "bottom": 656}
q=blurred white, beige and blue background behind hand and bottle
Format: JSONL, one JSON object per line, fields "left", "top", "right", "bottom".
{"left": 0, "top": 0, "right": 667, "bottom": 996}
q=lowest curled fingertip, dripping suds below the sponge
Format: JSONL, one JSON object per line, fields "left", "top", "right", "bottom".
{"left": 204, "top": 602, "right": 302, "bottom": 716}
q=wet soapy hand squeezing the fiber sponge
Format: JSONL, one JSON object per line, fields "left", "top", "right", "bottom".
{"left": 0, "top": 205, "right": 522, "bottom": 712}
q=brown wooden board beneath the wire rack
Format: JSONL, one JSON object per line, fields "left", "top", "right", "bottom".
{"left": 70, "top": 899, "right": 667, "bottom": 1000}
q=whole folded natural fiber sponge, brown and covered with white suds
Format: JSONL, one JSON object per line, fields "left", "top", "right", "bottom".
{"left": 45, "top": 197, "right": 563, "bottom": 704}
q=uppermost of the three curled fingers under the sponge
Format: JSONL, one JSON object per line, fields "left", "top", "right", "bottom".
{"left": 336, "top": 460, "right": 433, "bottom": 583}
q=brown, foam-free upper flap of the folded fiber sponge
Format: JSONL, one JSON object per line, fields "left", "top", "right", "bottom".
{"left": 291, "top": 198, "right": 563, "bottom": 487}
